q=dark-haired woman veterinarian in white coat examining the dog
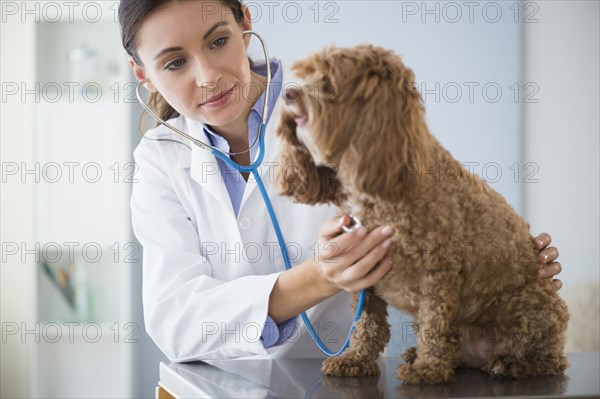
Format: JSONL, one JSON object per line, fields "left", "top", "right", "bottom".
{"left": 119, "top": 0, "right": 560, "bottom": 361}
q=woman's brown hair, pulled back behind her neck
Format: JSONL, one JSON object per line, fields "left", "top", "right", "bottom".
{"left": 119, "top": 0, "right": 244, "bottom": 124}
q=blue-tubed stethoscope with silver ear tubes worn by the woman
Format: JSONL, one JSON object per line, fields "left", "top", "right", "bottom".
{"left": 135, "top": 30, "right": 366, "bottom": 356}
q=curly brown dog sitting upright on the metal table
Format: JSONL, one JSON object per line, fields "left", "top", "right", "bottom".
{"left": 277, "top": 45, "right": 569, "bottom": 384}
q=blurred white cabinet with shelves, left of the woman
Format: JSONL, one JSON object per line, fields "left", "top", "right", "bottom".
{"left": 30, "top": 10, "right": 137, "bottom": 397}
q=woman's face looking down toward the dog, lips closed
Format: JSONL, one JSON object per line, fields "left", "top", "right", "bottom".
{"left": 132, "top": 1, "right": 257, "bottom": 131}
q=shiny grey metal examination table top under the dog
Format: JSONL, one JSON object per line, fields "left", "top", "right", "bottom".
{"left": 159, "top": 352, "right": 600, "bottom": 398}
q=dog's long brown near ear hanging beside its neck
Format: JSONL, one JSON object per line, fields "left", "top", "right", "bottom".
{"left": 340, "top": 66, "right": 430, "bottom": 201}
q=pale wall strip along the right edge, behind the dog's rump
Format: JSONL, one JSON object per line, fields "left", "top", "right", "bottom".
{"left": 524, "top": 1, "right": 600, "bottom": 351}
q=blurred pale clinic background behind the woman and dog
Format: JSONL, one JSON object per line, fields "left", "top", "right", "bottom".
{"left": 0, "top": 0, "right": 600, "bottom": 398}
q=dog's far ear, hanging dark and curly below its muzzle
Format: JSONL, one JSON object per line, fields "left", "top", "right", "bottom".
{"left": 276, "top": 112, "right": 342, "bottom": 205}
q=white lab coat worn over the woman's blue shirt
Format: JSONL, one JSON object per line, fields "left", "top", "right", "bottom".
{"left": 131, "top": 69, "right": 352, "bottom": 361}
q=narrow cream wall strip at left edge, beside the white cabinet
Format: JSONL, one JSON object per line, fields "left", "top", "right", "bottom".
{"left": 0, "top": 15, "right": 36, "bottom": 398}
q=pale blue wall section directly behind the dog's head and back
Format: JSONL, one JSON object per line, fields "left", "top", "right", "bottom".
{"left": 255, "top": 0, "right": 522, "bottom": 211}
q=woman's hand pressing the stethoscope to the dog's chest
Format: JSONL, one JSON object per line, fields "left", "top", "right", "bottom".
{"left": 313, "top": 215, "right": 393, "bottom": 293}
